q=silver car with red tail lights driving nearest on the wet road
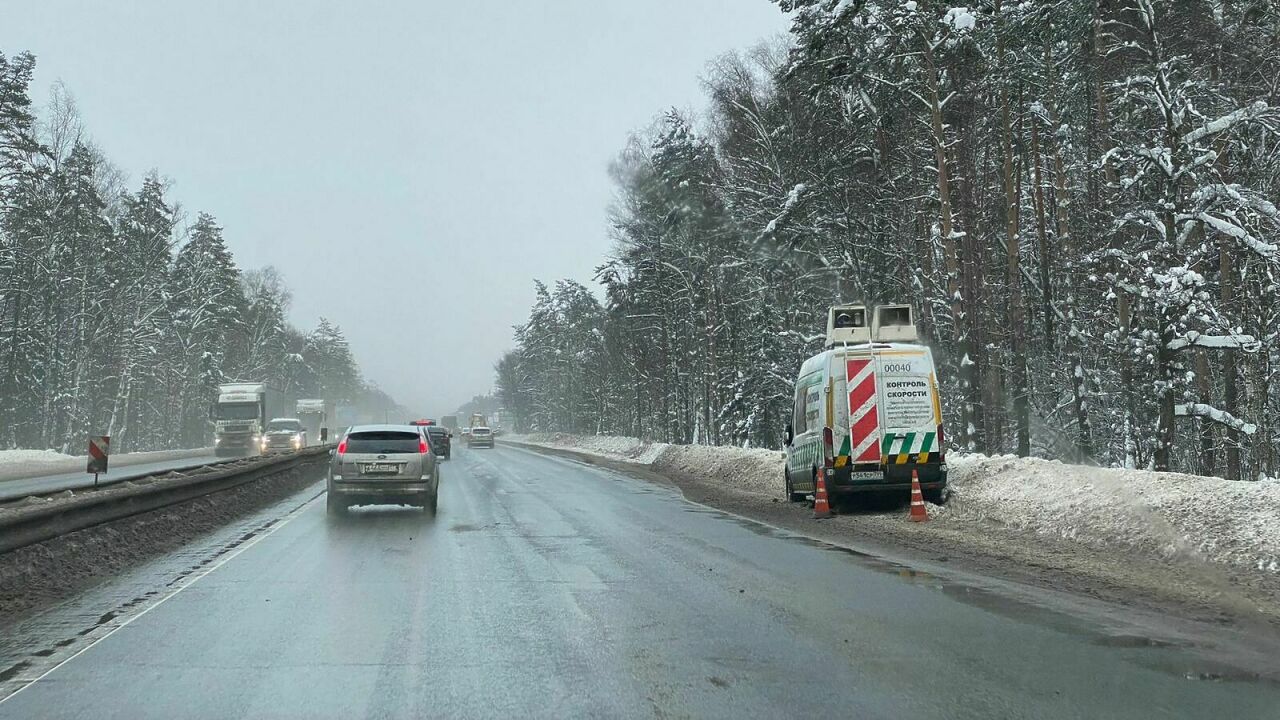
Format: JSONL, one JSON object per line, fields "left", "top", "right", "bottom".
{"left": 328, "top": 425, "right": 440, "bottom": 515}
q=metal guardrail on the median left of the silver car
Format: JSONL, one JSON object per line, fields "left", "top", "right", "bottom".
{"left": 0, "top": 446, "right": 329, "bottom": 552}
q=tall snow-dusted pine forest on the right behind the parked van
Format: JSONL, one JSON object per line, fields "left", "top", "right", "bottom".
{"left": 497, "top": 0, "right": 1280, "bottom": 479}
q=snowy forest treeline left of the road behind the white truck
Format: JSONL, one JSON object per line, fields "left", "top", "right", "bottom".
{"left": 0, "top": 53, "right": 399, "bottom": 452}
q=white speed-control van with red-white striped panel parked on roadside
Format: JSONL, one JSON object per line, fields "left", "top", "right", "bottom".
{"left": 786, "top": 305, "right": 947, "bottom": 502}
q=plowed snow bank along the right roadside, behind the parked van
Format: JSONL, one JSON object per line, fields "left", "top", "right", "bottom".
{"left": 509, "top": 434, "right": 1280, "bottom": 574}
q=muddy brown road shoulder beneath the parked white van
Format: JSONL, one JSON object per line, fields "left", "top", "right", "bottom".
{"left": 504, "top": 441, "right": 1280, "bottom": 633}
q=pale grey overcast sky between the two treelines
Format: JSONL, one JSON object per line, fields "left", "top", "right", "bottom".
{"left": 0, "top": 0, "right": 787, "bottom": 414}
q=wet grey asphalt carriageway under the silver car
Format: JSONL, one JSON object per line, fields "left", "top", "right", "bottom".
{"left": 0, "top": 447, "right": 1280, "bottom": 719}
